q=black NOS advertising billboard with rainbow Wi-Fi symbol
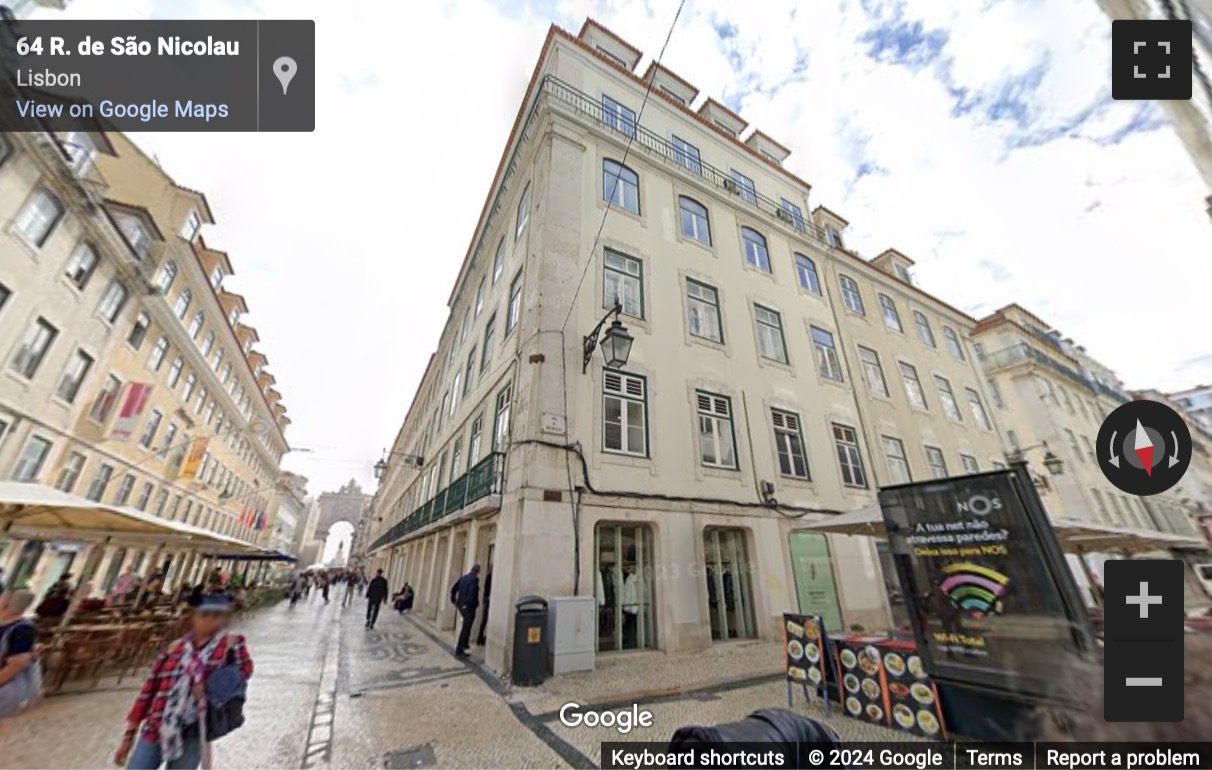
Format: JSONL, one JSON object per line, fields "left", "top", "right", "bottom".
{"left": 880, "top": 470, "right": 1088, "bottom": 695}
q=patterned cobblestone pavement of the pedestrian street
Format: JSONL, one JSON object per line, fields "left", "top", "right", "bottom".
{"left": 0, "top": 597, "right": 907, "bottom": 769}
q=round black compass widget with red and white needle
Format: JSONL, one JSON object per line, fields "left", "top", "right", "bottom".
{"left": 1097, "top": 401, "right": 1191, "bottom": 496}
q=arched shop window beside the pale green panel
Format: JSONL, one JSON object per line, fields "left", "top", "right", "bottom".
{"left": 703, "top": 527, "right": 758, "bottom": 640}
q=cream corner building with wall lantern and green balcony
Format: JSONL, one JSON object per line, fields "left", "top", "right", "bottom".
{"left": 368, "top": 21, "right": 1004, "bottom": 671}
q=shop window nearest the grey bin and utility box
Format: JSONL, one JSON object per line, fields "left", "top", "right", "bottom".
{"left": 594, "top": 524, "right": 657, "bottom": 652}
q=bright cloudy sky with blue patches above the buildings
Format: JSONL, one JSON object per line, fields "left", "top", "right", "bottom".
{"left": 49, "top": 0, "right": 1212, "bottom": 491}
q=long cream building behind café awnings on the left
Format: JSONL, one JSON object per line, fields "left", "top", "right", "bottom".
{"left": 0, "top": 127, "right": 290, "bottom": 591}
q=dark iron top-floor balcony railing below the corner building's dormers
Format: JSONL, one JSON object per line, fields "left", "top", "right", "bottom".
{"left": 539, "top": 75, "right": 828, "bottom": 244}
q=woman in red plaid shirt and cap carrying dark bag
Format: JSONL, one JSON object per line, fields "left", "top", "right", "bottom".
{"left": 114, "top": 594, "right": 252, "bottom": 770}
